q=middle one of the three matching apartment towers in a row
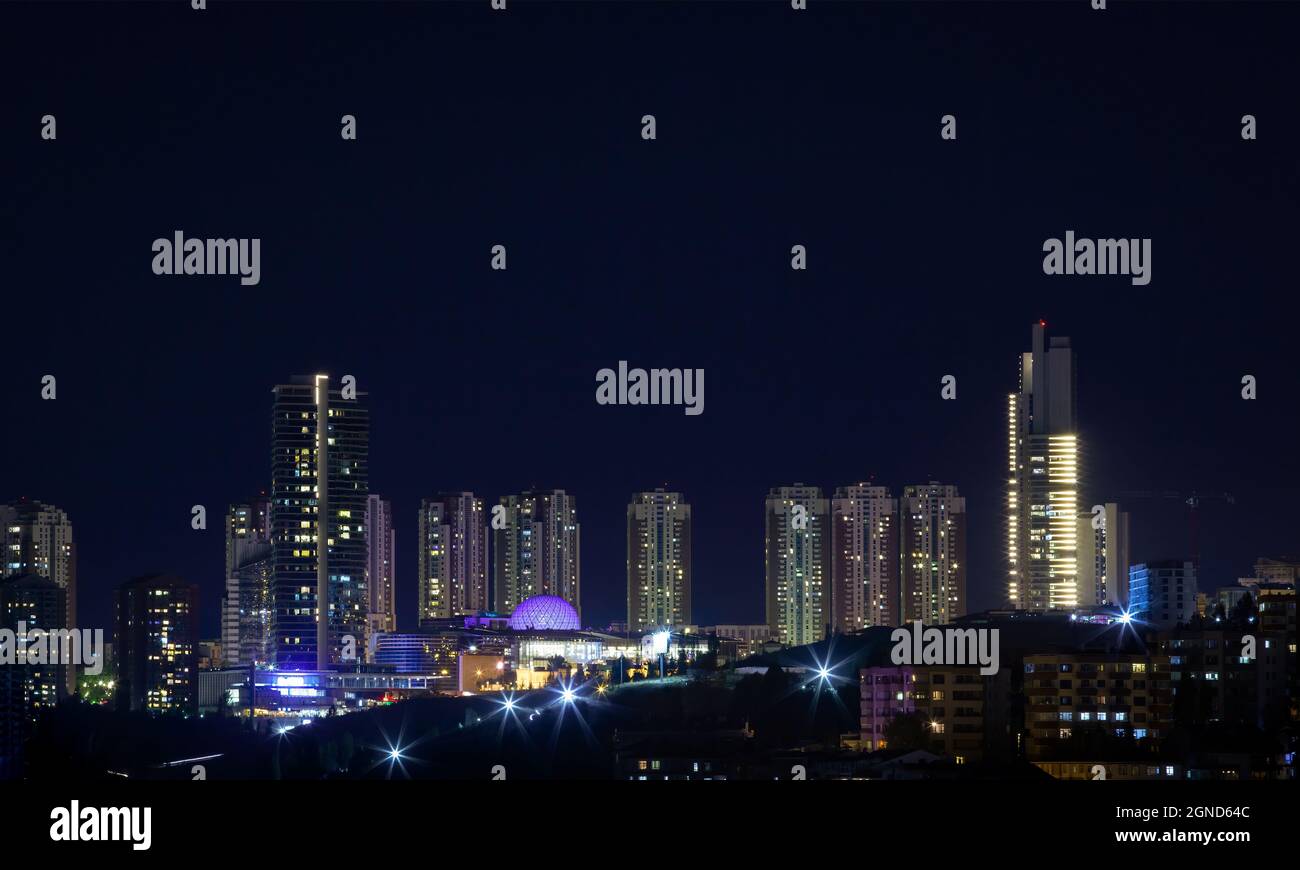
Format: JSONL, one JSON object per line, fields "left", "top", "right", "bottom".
{"left": 831, "top": 484, "right": 900, "bottom": 632}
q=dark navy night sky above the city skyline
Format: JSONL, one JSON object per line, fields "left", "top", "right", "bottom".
{"left": 0, "top": 0, "right": 1300, "bottom": 635}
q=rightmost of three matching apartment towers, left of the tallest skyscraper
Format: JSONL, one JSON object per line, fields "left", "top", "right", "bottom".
{"left": 898, "top": 481, "right": 966, "bottom": 626}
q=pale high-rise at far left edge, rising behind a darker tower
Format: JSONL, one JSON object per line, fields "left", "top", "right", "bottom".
{"left": 0, "top": 498, "right": 77, "bottom": 693}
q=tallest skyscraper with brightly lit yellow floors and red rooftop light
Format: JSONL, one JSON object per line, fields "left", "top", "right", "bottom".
{"left": 1006, "top": 321, "right": 1080, "bottom": 611}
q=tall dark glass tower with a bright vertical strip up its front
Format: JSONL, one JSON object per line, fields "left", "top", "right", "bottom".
{"left": 270, "top": 375, "right": 371, "bottom": 670}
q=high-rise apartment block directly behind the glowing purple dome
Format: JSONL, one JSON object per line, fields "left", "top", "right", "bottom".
{"left": 493, "top": 489, "right": 582, "bottom": 614}
